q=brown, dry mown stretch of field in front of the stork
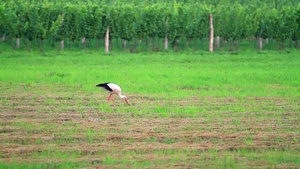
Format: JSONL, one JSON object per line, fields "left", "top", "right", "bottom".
{"left": 0, "top": 92, "right": 300, "bottom": 168}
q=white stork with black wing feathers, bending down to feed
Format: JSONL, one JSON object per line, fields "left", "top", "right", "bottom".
{"left": 96, "top": 83, "right": 130, "bottom": 106}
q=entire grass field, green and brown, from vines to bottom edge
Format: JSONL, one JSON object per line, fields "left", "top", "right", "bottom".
{"left": 0, "top": 47, "right": 300, "bottom": 168}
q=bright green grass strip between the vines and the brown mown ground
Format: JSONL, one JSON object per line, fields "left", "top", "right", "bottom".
{"left": 0, "top": 49, "right": 299, "bottom": 97}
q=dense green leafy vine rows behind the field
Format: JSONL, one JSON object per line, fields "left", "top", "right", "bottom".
{"left": 0, "top": 0, "right": 300, "bottom": 51}
